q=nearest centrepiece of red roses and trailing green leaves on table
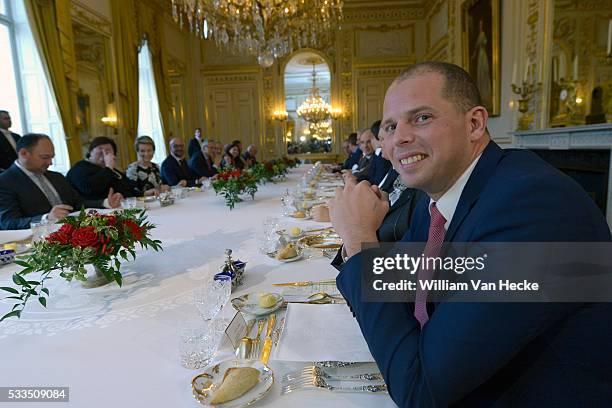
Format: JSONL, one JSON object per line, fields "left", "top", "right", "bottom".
{"left": 0, "top": 209, "right": 162, "bottom": 321}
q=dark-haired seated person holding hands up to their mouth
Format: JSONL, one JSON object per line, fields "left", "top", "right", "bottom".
{"left": 66, "top": 136, "right": 143, "bottom": 200}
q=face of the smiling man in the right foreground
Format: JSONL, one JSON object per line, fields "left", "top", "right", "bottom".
{"left": 380, "top": 72, "right": 480, "bottom": 200}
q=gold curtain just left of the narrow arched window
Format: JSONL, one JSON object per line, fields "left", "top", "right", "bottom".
{"left": 111, "top": 0, "right": 140, "bottom": 161}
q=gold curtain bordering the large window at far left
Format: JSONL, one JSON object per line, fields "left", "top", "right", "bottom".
{"left": 24, "top": 0, "right": 82, "bottom": 163}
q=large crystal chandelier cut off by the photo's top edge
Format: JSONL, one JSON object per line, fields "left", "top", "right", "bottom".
{"left": 172, "top": 0, "right": 343, "bottom": 68}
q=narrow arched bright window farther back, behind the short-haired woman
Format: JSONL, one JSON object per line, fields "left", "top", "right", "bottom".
{"left": 138, "top": 41, "right": 166, "bottom": 164}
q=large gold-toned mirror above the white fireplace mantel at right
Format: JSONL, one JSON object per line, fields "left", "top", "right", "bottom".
{"left": 549, "top": 0, "right": 612, "bottom": 127}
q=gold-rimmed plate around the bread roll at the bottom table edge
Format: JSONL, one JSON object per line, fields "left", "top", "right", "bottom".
{"left": 191, "top": 360, "right": 274, "bottom": 408}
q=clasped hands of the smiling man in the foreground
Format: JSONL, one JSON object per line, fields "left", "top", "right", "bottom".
{"left": 328, "top": 180, "right": 389, "bottom": 257}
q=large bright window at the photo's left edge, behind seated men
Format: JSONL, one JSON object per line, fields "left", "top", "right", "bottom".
{"left": 0, "top": 0, "right": 70, "bottom": 173}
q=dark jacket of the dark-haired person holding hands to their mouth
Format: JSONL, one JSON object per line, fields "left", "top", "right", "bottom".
{"left": 66, "top": 160, "right": 143, "bottom": 200}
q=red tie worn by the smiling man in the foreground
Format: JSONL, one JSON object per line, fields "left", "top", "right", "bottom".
{"left": 414, "top": 203, "right": 446, "bottom": 327}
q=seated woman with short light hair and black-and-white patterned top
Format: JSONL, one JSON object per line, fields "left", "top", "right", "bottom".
{"left": 125, "top": 136, "right": 170, "bottom": 195}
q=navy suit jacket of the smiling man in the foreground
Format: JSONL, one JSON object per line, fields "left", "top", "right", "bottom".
{"left": 337, "top": 142, "right": 612, "bottom": 407}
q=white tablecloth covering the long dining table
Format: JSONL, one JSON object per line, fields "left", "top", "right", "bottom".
{"left": 0, "top": 167, "right": 395, "bottom": 408}
